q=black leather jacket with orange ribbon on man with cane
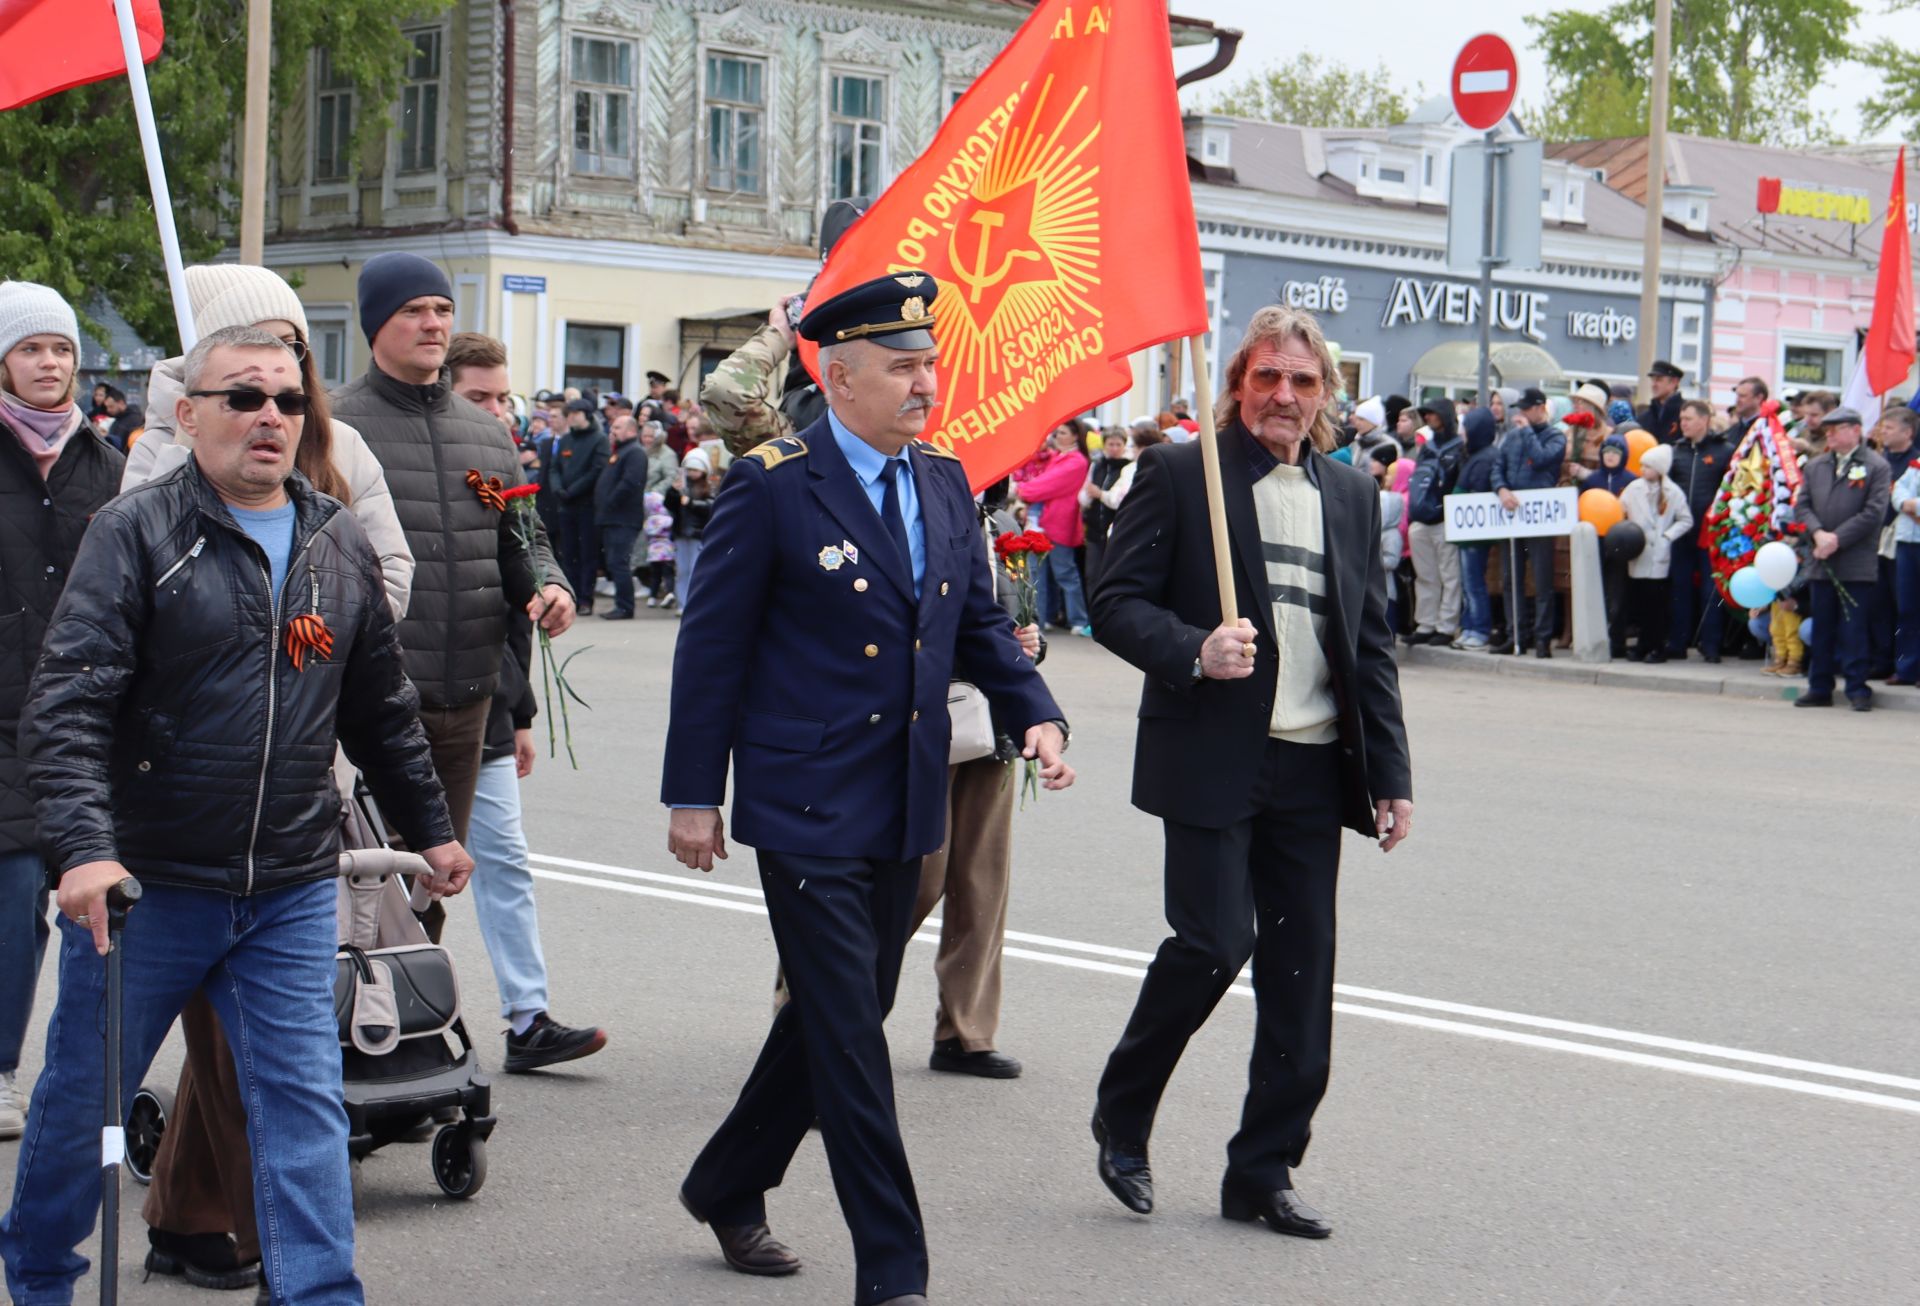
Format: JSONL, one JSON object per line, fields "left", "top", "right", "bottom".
{"left": 19, "top": 461, "right": 453, "bottom": 893}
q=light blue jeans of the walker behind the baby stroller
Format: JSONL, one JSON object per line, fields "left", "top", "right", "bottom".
{"left": 467, "top": 757, "right": 547, "bottom": 1020}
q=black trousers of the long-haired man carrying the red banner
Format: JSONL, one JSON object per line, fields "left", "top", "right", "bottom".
{"left": 1098, "top": 739, "right": 1340, "bottom": 1189}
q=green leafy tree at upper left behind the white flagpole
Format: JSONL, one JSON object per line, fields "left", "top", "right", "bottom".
{"left": 0, "top": 0, "right": 453, "bottom": 348}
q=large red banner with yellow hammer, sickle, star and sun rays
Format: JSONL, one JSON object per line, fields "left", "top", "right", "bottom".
{"left": 803, "top": 0, "right": 1208, "bottom": 490}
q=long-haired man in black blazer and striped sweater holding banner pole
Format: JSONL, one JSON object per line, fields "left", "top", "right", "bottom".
{"left": 1092, "top": 307, "right": 1413, "bottom": 1237}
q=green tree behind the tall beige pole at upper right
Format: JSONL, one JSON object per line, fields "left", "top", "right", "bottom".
{"left": 1526, "top": 0, "right": 1860, "bottom": 146}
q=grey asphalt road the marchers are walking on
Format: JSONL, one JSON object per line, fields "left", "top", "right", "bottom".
{"left": 0, "top": 615, "right": 1920, "bottom": 1306}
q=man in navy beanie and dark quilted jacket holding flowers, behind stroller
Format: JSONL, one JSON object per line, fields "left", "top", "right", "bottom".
{"left": 332, "top": 254, "right": 574, "bottom": 939}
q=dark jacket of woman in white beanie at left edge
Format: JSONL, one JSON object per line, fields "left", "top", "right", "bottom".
{"left": 0, "top": 419, "right": 127, "bottom": 853}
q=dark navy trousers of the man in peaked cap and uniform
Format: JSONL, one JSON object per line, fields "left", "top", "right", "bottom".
{"left": 684, "top": 849, "right": 927, "bottom": 1306}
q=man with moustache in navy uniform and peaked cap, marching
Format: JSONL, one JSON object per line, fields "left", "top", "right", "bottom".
{"left": 660, "top": 271, "right": 1073, "bottom": 1306}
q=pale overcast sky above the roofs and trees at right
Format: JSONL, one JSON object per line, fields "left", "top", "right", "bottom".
{"left": 1173, "top": 0, "right": 1920, "bottom": 140}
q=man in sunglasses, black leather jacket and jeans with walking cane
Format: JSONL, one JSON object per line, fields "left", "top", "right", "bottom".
{"left": 0, "top": 327, "right": 472, "bottom": 1306}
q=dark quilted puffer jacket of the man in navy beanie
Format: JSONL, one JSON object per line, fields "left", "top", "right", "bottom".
{"left": 332, "top": 367, "right": 570, "bottom": 707}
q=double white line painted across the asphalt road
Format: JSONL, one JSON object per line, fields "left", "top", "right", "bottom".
{"left": 530, "top": 855, "right": 1920, "bottom": 1114}
